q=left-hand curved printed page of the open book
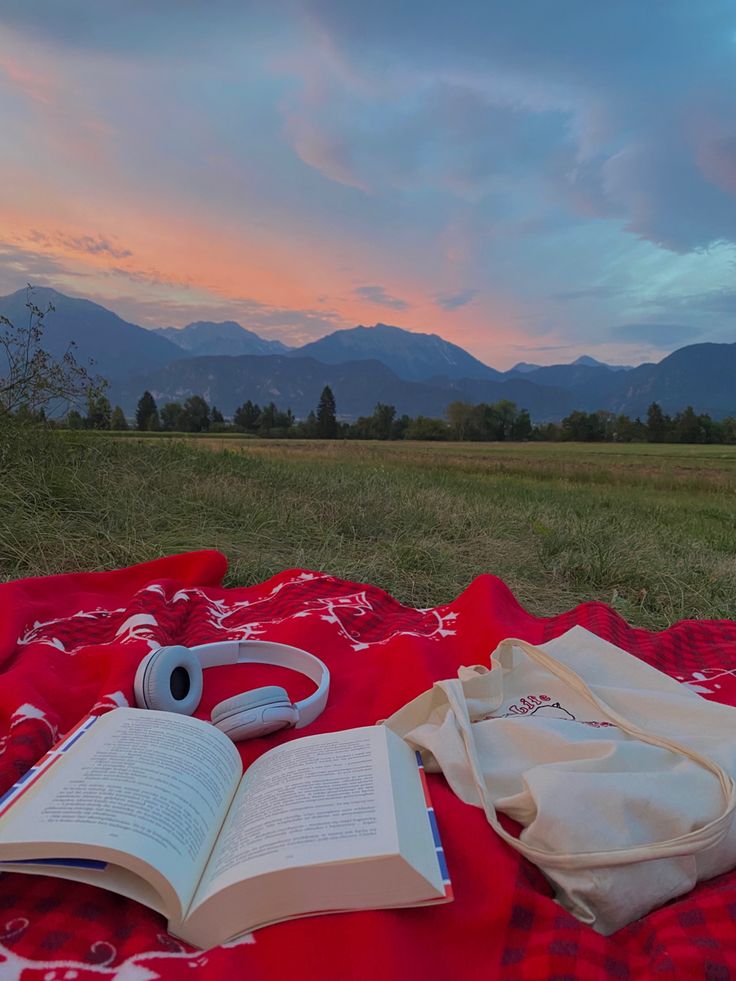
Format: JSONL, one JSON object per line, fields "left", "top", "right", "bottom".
{"left": 0, "top": 708, "right": 242, "bottom": 913}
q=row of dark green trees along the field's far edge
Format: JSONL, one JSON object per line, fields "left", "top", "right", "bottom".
{"left": 54, "top": 385, "right": 736, "bottom": 443}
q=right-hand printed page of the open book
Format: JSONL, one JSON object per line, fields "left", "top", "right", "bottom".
{"left": 192, "top": 726, "right": 398, "bottom": 907}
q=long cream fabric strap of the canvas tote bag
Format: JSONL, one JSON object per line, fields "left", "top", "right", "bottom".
{"left": 445, "top": 639, "right": 736, "bottom": 869}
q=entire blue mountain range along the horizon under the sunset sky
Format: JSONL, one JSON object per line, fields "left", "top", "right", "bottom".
{"left": 0, "top": 288, "right": 736, "bottom": 422}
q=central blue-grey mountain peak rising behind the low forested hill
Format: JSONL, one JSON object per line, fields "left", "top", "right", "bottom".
{"left": 290, "top": 324, "right": 503, "bottom": 381}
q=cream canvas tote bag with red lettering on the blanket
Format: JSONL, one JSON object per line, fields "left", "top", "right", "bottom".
{"left": 385, "top": 627, "right": 736, "bottom": 934}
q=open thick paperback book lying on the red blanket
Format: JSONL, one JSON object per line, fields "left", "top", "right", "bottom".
{"left": 0, "top": 708, "right": 452, "bottom": 948}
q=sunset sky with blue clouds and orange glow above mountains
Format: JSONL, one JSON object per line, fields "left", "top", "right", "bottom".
{"left": 0, "top": 0, "right": 736, "bottom": 368}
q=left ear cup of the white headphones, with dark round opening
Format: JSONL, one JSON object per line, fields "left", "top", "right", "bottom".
{"left": 134, "top": 646, "right": 202, "bottom": 715}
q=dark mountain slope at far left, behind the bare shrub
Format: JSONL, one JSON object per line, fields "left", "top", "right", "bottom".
{"left": 0, "top": 287, "right": 183, "bottom": 379}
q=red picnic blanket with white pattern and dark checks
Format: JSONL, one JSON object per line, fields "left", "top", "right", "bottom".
{"left": 0, "top": 551, "right": 736, "bottom": 981}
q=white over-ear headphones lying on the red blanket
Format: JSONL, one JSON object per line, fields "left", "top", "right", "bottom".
{"left": 133, "top": 640, "right": 330, "bottom": 742}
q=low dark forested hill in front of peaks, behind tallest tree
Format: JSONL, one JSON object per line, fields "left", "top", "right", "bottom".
{"left": 111, "top": 355, "right": 575, "bottom": 421}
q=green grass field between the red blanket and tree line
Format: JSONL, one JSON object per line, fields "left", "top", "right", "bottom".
{"left": 0, "top": 433, "right": 736, "bottom": 627}
